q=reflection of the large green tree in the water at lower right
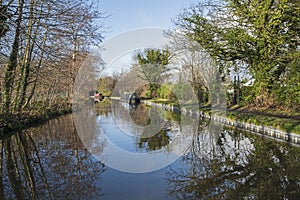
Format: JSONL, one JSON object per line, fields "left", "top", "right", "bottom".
{"left": 167, "top": 126, "right": 300, "bottom": 199}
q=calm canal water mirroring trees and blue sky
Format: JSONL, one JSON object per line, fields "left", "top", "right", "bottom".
{"left": 0, "top": 101, "right": 300, "bottom": 200}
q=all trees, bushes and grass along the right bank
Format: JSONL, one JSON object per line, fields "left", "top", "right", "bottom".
{"left": 94, "top": 0, "right": 300, "bottom": 133}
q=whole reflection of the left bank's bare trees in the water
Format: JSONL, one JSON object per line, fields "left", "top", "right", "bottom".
{"left": 0, "top": 115, "right": 104, "bottom": 199}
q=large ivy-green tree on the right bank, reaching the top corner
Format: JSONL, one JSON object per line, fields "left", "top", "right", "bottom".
{"left": 176, "top": 0, "right": 300, "bottom": 107}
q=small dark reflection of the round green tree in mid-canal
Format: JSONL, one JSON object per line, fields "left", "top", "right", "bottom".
{"left": 139, "top": 130, "right": 170, "bottom": 151}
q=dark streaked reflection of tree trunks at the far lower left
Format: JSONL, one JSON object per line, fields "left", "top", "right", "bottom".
{"left": 0, "top": 132, "right": 50, "bottom": 199}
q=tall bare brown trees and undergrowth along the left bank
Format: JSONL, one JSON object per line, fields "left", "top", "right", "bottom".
{"left": 0, "top": 0, "right": 105, "bottom": 132}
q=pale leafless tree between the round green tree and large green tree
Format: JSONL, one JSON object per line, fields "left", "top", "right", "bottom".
{"left": 166, "top": 30, "right": 225, "bottom": 107}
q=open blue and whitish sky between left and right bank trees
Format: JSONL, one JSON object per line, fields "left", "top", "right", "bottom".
{"left": 98, "top": 0, "right": 199, "bottom": 75}
